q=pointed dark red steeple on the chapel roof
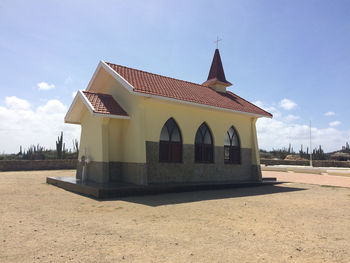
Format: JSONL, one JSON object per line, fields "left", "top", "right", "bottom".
{"left": 202, "top": 49, "right": 232, "bottom": 92}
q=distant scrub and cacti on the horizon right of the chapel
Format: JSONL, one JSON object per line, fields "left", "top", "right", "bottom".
{"left": 260, "top": 142, "right": 350, "bottom": 161}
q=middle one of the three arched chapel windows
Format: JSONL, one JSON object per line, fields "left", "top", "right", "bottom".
{"left": 194, "top": 123, "right": 214, "bottom": 163}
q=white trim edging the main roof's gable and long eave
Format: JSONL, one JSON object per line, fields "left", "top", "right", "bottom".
{"left": 87, "top": 60, "right": 272, "bottom": 119}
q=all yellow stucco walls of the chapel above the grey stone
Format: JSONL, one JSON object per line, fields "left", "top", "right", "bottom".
{"left": 79, "top": 66, "right": 259, "bottom": 164}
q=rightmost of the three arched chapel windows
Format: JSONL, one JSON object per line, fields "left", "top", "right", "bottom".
{"left": 224, "top": 126, "right": 241, "bottom": 164}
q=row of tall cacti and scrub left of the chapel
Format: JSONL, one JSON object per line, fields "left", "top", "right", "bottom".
{"left": 0, "top": 132, "right": 79, "bottom": 160}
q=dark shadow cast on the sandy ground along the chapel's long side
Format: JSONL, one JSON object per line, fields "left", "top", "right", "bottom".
{"left": 108, "top": 185, "right": 307, "bottom": 207}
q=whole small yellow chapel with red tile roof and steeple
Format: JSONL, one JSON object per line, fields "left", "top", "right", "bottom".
{"left": 65, "top": 49, "right": 272, "bottom": 186}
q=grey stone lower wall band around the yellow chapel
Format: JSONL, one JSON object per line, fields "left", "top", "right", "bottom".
{"left": 77, "top": 142, "right": 261, "bottom": 185}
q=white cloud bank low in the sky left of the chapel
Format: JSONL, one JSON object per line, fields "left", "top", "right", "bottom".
{"left": 0, "top": 97, "right": 80, "bottom": 153}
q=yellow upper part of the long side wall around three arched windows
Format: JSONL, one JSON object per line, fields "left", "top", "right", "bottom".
{"left": 145, "top": 99, "right": 252, "bottom": 148}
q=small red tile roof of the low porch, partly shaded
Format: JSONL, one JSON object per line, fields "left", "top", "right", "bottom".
{"left": 83, "top": 91, "right": 128, "bottom": 116}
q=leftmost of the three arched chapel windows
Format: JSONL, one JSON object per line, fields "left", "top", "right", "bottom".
{"left": 159, "top": 118, "right": 182, "bottom": 162}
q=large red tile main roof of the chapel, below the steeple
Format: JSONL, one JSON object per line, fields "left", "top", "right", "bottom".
{"left": 106, "top": 62, "right": 272, "bottom": 117}
